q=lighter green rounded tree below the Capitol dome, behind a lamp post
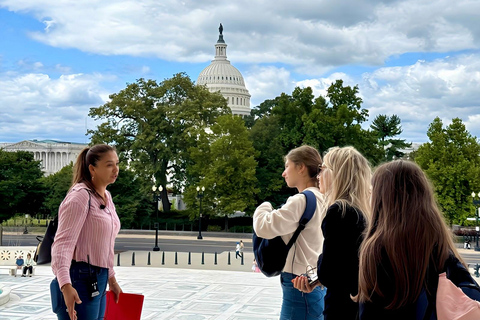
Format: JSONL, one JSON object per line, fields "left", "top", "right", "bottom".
{"left": 184, "top": 115, "right": 258, "bottom": 215}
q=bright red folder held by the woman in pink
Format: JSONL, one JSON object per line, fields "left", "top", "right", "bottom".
{"left": 104, "top": 291, "right": 144, "bottom": 320}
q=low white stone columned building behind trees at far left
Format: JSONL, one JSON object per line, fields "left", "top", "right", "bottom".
{"left": 0, "top": 139, "right": 87, "bottom": 176}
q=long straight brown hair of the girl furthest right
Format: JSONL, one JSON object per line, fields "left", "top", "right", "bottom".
{"left": 357, "top": 160, "right": 465, "bottom": 309}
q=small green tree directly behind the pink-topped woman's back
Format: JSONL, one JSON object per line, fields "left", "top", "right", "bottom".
{"left": 42, "top": 163, "right": 73, "bottom": 216}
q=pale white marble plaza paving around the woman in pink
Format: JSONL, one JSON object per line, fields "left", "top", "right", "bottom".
{"left": 0, "top": 266, "right": 282, "bottom": 320}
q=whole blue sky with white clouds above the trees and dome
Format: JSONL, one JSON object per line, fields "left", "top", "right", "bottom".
{"left": 0, "top": 0, "right": 480, "bottom": 142}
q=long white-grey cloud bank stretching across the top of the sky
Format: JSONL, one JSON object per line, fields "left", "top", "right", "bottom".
{"left": 0, "top": 0, "right": 480, "bottom": 70}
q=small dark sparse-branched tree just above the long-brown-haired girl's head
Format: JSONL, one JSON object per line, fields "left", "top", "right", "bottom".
{"left": 370, "top": 114, "right": 412, "bottom": 161}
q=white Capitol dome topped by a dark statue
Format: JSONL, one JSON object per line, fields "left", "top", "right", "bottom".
{"left": 197, "top": 24, "right": 250, "bottom": 116}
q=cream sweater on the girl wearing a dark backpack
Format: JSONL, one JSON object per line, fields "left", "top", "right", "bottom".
{"left": 253, "top": 187, "right": 326, "bottom": 275}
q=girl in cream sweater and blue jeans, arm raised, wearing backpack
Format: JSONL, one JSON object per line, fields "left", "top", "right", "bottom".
{"left": 253, "top": 146, "right": 326, "bottom": 320}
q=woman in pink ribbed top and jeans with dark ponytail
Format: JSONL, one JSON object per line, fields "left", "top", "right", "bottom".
{"left": 50, "top": 144, "right": 122, "bottom": 320}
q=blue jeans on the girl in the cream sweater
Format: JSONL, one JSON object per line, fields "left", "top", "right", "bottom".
{"left": 280, "top": 272, "right": 327, "bottom": 320}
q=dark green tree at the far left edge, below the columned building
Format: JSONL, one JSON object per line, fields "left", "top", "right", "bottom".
{"left": 0, "top": 150, "right": 45, "bottom": 223}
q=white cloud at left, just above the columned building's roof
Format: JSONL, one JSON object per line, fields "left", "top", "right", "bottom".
{"left": 0, "top": 73, "right": 107, "bottom": 142}
